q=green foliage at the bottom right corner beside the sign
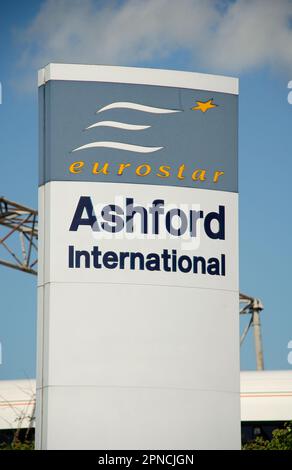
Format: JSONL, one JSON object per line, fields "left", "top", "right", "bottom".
{"left": 243, "top": 422, "right": 292, "bottom": 450}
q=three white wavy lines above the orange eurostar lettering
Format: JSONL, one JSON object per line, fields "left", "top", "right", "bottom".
{"left": 72, "top": 101, "right": 181, "bottom": 153}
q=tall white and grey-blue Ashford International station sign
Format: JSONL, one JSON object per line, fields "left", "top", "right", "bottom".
{"left": 37, "top": 64, "right": 240, "bottom": 449}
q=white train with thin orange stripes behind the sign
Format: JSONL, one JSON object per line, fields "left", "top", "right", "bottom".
{"left": 0, "top": 370, "right": 292, "bottom": 444}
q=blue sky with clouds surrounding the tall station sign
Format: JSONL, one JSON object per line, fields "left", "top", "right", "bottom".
{"left": 0, "top": 0, "right": 292, "bottom": 378}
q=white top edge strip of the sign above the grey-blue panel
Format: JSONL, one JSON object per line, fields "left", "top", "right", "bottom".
{"left": 38, "top": 63, "right": 239, "bottom": 95}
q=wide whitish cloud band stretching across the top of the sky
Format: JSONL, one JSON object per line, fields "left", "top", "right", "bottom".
{"left": 13, "top": 0, "right": 292, "bottom": 89}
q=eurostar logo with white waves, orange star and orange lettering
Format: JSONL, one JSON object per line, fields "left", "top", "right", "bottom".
{"left": 69, "top": 97, "right": 225, "bottom": 185}
